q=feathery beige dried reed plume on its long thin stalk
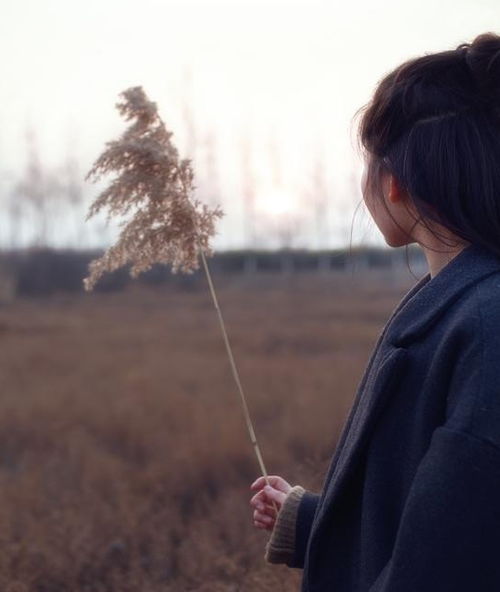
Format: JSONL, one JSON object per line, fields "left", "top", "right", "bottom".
{"left": 84, "top": 87, "right": 276, "bottom": 494}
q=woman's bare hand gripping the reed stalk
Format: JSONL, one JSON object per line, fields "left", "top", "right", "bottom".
{"left": 250, "top": 475, "right": 292, "bottom": 530}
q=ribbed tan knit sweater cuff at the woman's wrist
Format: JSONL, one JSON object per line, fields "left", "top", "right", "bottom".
{"left": 265, "top": 485, "right": 305, "bottom": 563}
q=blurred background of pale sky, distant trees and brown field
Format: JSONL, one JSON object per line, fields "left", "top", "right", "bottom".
{"left": 0, "top": 0, "right": 500, "bottom": 592}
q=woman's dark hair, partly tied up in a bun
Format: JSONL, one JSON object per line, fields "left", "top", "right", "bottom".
{"left": 357, "top": 33, "right": 500, "bottom": 255}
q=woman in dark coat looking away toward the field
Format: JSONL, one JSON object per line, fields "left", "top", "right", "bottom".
{"left": 251, "top": 33, "right": 500, "bottom": 592}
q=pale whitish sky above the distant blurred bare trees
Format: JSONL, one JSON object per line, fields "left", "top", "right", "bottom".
{"left": 0, "top": 0, "right": 500, "bottom": 248}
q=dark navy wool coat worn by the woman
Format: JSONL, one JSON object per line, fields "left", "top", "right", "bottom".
{"left": 290, "top": 246, "right": 500, "bottom": 592}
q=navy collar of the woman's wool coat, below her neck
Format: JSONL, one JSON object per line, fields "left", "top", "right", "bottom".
{"left": 386, "top": 245, "right": 500, "bottom": 347}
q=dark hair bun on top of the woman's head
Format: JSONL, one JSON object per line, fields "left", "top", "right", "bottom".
{"left": 457, "top": 33, "right": 500, "bottom": 109}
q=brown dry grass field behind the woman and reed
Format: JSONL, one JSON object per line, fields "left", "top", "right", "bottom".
{"left": 0, "top": 274, "right": 415, "bottom": 592}
